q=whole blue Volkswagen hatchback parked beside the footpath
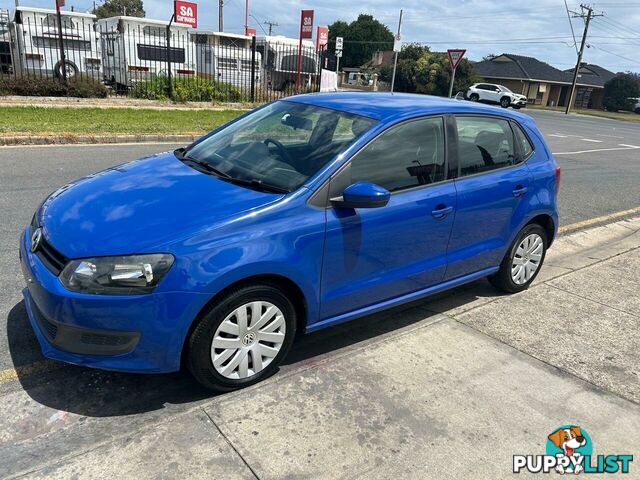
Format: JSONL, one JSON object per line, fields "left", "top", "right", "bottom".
{"left": 20, "top": 93, "right": 560, "bottom": 391}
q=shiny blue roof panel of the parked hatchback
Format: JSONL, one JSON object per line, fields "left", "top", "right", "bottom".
{"left": 284, "top": 92, "right": 532, "bottom": 123}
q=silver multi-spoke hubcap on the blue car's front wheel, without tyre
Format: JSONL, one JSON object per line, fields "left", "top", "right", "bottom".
{"left": 211, "top": 302, "right": 286, "bottom": 380}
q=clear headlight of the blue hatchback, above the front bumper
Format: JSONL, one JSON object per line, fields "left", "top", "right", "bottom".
{"left": 60, "top": 253, "right": 173, "bottom": 295}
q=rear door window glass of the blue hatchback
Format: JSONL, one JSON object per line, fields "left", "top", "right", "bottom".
{"left": 456, "top": 117, "right": 517, "bottom": 177}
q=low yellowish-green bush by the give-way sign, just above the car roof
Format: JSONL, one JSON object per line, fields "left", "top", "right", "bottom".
{"left": 380, "top": 44, "right": 480, "bottom": 96}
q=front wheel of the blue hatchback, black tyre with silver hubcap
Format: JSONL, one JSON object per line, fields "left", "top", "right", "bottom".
{"left": 187, "top": 284, "right": 297, "bottom": 392}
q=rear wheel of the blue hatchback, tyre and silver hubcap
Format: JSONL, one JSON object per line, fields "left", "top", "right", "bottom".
{"left": 489, "top": 223, "right": 548, "bottom": 293}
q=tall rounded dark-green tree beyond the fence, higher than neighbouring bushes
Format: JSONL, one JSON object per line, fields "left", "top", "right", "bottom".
{"left": 329, "top": 13, "right": 393, "bottom": 67}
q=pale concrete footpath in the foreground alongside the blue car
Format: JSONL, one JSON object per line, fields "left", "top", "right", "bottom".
{"left": 0, "top": 217, "right": 640, "bottom": 480}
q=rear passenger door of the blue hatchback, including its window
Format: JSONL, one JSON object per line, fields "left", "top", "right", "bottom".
{"left": 446, "top": 115, "right": 531, "bottom": 279}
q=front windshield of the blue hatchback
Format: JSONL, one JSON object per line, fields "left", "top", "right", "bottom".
{"left": 176, "top": 100, "right": 376, "bottom": 192}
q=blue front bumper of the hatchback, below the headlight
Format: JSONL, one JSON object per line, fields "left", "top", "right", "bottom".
{"left": 20, "top": 227, "right": 207, "bottom": 373}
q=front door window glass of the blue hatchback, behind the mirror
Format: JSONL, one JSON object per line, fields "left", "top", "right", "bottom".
{"left": 351, "top": 118, "right": 445, "bottom": 192}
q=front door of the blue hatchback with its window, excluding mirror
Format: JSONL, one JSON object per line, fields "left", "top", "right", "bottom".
{"left": 321, "top": 117, "right": 456, "bottom": 320}
